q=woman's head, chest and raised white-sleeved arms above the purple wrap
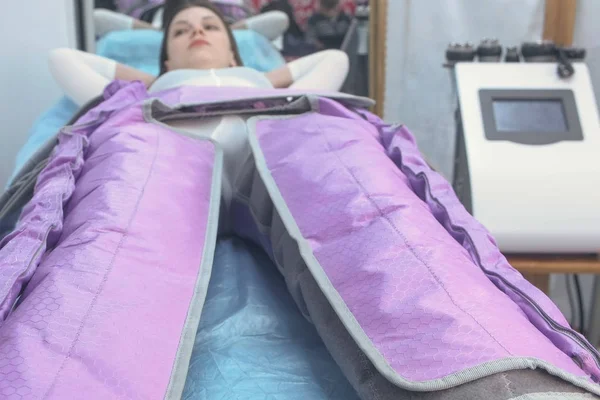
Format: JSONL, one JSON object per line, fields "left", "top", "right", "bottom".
{"left": 50, "top": 4, "right": 348, "bottom": 105}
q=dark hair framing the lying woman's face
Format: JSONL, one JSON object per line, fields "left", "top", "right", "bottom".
{"left": 159, "top": 0, "right": 244, "bottom": 75}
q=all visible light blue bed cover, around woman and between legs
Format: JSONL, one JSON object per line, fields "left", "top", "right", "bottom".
{"left": 13, "top": 31, "right": 358, "bottom": 400}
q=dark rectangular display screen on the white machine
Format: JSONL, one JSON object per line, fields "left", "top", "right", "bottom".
{"left": 492, "top": 99, "right": 568, "bottom": 133}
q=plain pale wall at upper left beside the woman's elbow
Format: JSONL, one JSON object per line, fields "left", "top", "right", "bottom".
{"left": 0, "top": 0, "right": 76, "bottom": 188}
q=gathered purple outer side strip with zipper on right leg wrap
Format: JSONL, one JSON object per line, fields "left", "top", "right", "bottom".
{"left": 376, "top": 116, "right": 600, "bottom": 380}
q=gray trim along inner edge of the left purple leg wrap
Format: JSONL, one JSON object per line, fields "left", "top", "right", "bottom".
{"left": 139, "top": 119, "right": 223, "bottom": 400}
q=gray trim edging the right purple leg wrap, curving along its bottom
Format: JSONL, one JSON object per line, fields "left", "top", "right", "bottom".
{"left": 247, "top": 115, "right": 600, "bottom": 395}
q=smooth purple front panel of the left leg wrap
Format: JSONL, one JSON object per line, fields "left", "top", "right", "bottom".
{"left": 0, "top": 117, "right": 214, "bottom": 399}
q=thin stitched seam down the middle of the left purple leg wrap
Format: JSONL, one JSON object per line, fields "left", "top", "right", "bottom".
{"left": 42, "top": 129, "right": 160, "bottom": 399}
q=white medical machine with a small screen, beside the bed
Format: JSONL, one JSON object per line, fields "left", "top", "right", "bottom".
{"left": 453, "top": 42, "right": 600, "bottom": 253}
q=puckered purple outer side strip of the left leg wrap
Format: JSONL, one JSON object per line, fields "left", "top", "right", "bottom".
{"left": 0, "top": 135, "right": 87, "bottom": 327}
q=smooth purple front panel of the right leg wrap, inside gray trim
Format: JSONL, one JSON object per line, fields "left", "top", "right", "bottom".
{"left": 256, "top": 114, "right": 584, "bottom": 381}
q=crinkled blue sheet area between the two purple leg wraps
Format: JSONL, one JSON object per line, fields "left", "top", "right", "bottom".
{"left": 183, "top": 238, "right": 358, "bottom": 400}
